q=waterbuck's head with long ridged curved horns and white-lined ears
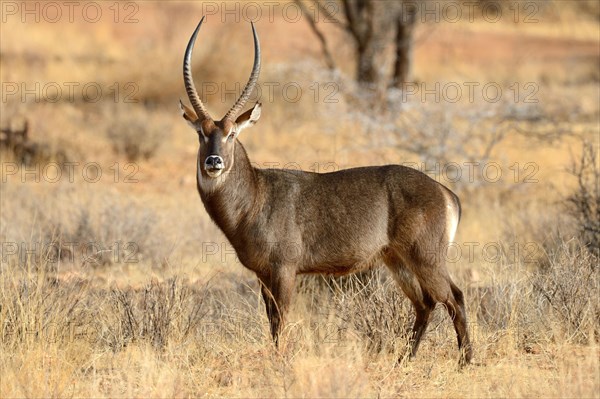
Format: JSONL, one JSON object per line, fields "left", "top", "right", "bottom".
{"left": 179, "top": 17, "right": 261, "bottom": 179}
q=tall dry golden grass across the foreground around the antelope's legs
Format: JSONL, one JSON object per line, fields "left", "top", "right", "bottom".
{"left": 0, "top": 242, "right": 600, "bottom": 397}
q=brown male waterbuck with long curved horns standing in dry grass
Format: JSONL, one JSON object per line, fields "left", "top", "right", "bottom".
{"left": 180, "top": 18, "right": 472, "bottom": 364}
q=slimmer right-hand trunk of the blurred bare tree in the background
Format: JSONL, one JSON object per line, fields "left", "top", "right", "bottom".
{"left": 391, "top": 7, "right": 416, "bottom": 88}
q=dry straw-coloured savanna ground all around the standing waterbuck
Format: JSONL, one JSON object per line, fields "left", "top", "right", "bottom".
{"left": 0, "top": 1, "right": 600, "bottom": 398}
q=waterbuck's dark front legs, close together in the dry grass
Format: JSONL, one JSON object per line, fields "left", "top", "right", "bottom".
{"left": 259, "top": 268, "right": 296, "bottom": 346}
